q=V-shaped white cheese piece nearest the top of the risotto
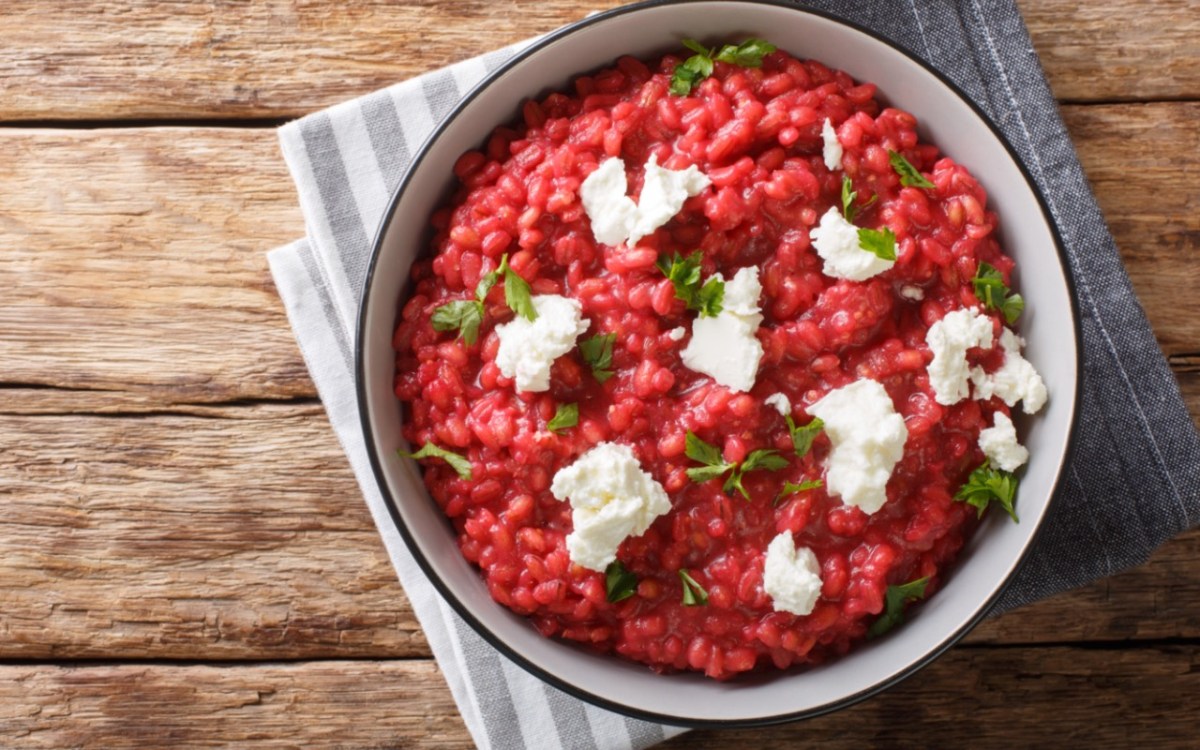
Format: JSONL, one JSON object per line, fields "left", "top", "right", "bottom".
{"left": 580, "top": 155, "right": 712, "bottom": 245}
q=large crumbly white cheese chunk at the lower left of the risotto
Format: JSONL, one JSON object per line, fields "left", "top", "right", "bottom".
{"left": 550, "top": 443, "right": 671, "bottom": 571}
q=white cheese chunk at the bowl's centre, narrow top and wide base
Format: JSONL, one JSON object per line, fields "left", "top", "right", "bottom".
{"left": 680, "top": 266, "right": 762, "bottom": 391}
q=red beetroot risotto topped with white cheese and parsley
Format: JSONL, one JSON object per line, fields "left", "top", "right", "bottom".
{"left": 394, "top": 40, "right": 1046, "bottom": 679}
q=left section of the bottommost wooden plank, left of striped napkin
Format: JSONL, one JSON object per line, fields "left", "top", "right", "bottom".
{"left": 0, "top": 661, "right": 473, "bottom": 750}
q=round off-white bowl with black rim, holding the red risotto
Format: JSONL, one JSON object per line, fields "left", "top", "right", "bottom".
{"left": 356, "top": 1, "right": 1080, "bottom": 726}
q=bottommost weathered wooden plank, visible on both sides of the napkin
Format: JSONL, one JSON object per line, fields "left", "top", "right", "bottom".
{"left": 0, "top": 646, "right": 1200, "bottom": 750}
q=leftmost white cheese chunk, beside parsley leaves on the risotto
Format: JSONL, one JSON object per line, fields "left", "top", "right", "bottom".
{"left": 496, "top": 294, "right": 589, "bottom": 392}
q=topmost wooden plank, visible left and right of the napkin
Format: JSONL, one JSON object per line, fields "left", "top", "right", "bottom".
{"left": 0, "top": 0, "right": 1200, "bottom": 121}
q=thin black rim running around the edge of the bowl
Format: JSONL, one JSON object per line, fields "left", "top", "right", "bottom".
{"left": 354, "top": 0, "right": 1084, "bottom": 728}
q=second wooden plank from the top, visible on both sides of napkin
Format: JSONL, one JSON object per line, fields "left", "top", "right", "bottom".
{"left": 0, "top": 103, "right": 1200, "bottom": 403}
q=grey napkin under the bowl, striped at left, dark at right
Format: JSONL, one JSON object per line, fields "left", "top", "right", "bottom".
{"left": 269, "top": 0, "right": 1200, "bottom": 750}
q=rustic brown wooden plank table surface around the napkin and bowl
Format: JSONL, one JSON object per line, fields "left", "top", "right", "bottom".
{"left": 0, "top": 0, "right": 1200, "bottom": 749}
